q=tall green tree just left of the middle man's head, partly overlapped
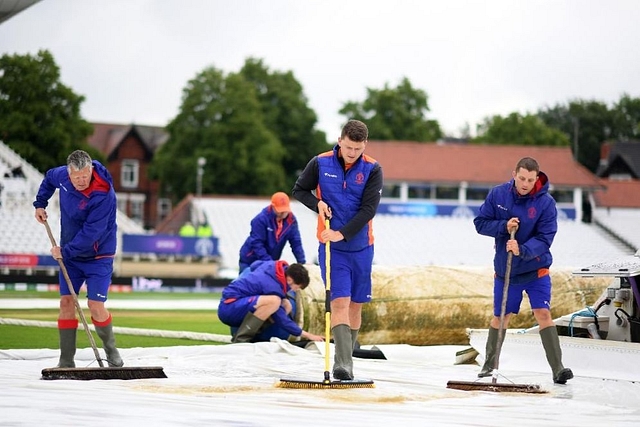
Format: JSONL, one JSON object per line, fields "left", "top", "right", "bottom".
{"left": 240, "top": 58, "right": 330, "bottom": 187}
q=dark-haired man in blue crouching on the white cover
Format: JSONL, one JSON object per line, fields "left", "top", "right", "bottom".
{"left": 218, "top": 261, "right": 323, "bottom": 343}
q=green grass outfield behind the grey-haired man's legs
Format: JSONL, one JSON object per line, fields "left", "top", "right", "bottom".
{"left": 0, "top": 291, "right": 229, "bottom": 350}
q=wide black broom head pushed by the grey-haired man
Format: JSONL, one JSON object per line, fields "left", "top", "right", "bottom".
{"left": 42, "top": 366, "right": 167, "bottom": 380}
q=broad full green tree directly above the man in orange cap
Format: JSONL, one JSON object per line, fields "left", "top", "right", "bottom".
{"left": 150, "top": 67, "right": 285, "bottom": 201}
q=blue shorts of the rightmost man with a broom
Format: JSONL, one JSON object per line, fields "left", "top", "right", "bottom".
{"left": 493, "top": 274, "right": 551, "bottom": 316}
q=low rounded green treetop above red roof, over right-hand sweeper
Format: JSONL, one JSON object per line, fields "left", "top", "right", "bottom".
{"left": 473, "top": 113, "right": 569, "bottom": 146}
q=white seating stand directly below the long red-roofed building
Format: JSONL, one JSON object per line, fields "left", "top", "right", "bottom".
{"left": 194, "top": 198, "right": 634, "bottom": 269}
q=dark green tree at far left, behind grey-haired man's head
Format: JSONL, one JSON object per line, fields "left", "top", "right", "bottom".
{"left": 0, "top": 50, "right": 95, "bottom": 172}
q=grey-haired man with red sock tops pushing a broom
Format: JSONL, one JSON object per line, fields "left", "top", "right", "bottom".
{"left": 33, "top": 150, "right": 123, "bottom": 368}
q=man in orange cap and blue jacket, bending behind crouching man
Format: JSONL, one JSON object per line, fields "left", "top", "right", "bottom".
{"left": 238, "top": 191, "right": 306, "bottom": 273}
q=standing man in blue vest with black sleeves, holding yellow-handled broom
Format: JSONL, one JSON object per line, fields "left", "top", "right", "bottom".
{"left": 293, "top": 120, "right": 383, "bottom": 380}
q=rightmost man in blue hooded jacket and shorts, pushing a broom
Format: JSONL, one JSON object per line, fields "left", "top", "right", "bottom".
{"left": 474, "top": 157, "right": 573, "bottom": 384}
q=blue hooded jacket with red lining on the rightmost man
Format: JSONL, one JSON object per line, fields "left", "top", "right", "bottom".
{"left": 473, "top": 172, "right": 558, "bottom": 284}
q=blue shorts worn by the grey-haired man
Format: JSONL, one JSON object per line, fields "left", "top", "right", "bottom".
{"left": 58, "top": 258, "right": 113, "bottom": 302}
